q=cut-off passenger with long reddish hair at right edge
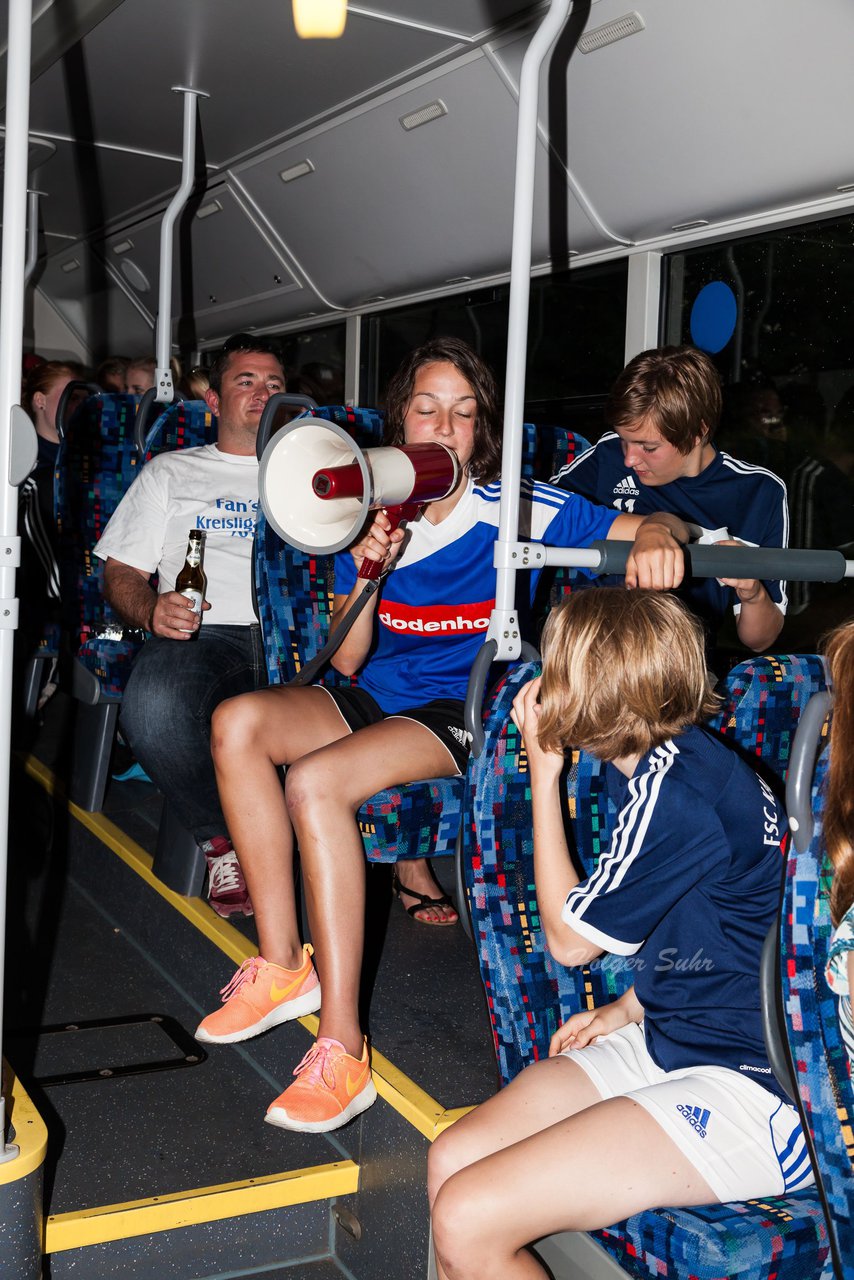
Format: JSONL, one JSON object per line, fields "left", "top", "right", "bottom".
{"left": 825, "top": 622, "right": 854, "bottom": 1068}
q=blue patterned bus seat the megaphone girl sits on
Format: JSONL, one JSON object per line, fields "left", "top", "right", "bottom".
{"left": 255, "top": 406, "right": 462, "bottom": 863}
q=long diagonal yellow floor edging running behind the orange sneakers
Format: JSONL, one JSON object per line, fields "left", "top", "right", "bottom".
{"left": 24, "top": 755, "right": 471, "bottom": 1142}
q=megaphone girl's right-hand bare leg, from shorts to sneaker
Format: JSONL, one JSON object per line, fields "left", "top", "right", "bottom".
{"left": 285, "top": 719, "right": 455, "bottom": 1057}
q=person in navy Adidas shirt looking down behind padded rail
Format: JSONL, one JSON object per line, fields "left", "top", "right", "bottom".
{"left": 553, "top": 347, "right": 789, "bottom": 653}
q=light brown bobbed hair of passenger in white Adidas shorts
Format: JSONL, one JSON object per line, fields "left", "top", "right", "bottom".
{"left": 539, "top": 586, "right": 720, "bottom": 760}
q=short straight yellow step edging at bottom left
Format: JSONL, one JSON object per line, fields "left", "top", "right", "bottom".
{"left": 45, "top": 1160, "right": 359, "bottom": 1253}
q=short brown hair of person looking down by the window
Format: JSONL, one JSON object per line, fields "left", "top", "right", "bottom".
{"left": 604, "top": 347, "right": 722, "bottom": 454}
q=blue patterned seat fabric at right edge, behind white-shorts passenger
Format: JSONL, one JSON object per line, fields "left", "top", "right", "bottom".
{"left": 780, "top": 745, "right": 854, "bottom": 1280}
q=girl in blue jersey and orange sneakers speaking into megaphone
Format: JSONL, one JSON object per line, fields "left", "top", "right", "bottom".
{"left": 196, "top": 338, "right": 688, "bottom": 1132}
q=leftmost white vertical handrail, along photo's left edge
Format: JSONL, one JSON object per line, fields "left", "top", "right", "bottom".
{"left": 0, "top": 0, "right": 32, "bottom": 1162}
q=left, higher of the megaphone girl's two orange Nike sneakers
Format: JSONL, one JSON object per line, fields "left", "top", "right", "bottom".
{"left": 196, "top": 943, "right": 320, "bottom": 1044}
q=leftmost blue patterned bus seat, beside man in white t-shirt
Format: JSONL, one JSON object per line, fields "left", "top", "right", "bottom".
{"left": 54, "top": 393, "right": 143, "bottom": 812}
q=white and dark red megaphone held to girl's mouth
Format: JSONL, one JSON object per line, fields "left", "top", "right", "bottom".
{"left": 259, "top": 417, "right": 461, "bottom": 579}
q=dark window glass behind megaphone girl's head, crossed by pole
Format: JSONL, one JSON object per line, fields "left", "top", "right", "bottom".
{"left": 361, "top": 260, "right": 627, "bottom": 435}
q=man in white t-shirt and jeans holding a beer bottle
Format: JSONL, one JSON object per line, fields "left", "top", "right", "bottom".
{"left": 95, "top": 334, "right": 284, "bottom": 916}
